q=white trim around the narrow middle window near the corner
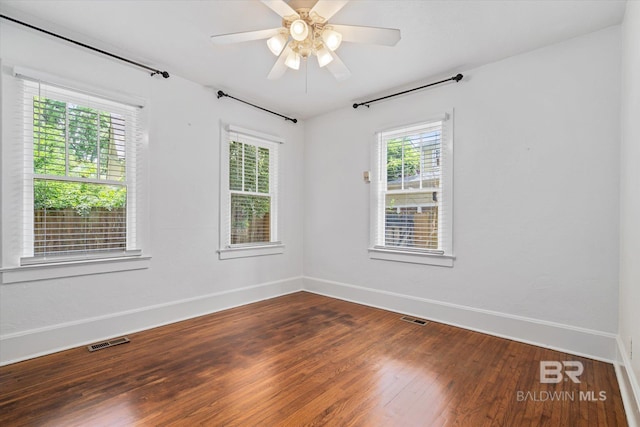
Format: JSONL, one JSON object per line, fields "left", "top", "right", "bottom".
{"left": 216, "top": 123, "right": 285, "bottom": 260}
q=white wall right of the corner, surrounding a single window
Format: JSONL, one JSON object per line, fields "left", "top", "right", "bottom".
{"left": 304, "top": 27, "right": 620, "bottom": 359}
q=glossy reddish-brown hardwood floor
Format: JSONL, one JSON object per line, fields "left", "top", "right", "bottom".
{"left": 0, "top": 292, "right": 626, "bottom": 426}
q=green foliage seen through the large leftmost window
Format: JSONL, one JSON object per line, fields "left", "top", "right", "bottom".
{"left": 33, "top": 97, "right": 127, "bottom": 216}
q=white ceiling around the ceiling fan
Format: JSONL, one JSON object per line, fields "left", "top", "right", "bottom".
{"left": 0, "top": 0, "right": 626, "bottom": 119}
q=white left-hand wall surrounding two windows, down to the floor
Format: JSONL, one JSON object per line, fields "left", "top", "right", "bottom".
{"left": 0, "top": 21, "right": 304, "bottom": 363}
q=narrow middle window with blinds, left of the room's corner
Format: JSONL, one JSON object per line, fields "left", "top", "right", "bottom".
{"left": 219, "top": 123, "right": 282, "bottom": 259}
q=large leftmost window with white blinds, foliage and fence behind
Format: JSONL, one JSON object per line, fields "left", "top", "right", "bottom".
{"left": 20, "top": 80, "right": 142, "bottom": 264}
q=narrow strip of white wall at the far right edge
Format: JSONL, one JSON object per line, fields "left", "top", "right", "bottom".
{"left": 619, "top": 1, "right": 640, "bottom": 422}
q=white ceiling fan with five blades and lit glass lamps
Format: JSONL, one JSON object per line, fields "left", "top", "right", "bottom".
{"left": 211, "top": 0, "right": 400, "bottom": 81}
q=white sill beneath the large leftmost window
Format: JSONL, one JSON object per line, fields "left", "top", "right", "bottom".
{"left": 0, "top": 256, "right": 151, "bottom": 284}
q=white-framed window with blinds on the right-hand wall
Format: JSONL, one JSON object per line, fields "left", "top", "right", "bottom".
{"left": 370, "top": 114, "right": 453, "bottom": 265}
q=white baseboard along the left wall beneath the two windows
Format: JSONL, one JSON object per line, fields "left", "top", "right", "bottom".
{"left": 0, "top": 277, "right": 303, "bottom": 366}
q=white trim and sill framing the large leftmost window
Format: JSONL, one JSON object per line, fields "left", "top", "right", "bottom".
{"left": 0, "top": 64, "right": 151, "bottom": 284}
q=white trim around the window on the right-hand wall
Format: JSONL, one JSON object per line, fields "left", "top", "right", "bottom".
{"left": 368, "top": 113, "right": 456, "bottom": 267}
